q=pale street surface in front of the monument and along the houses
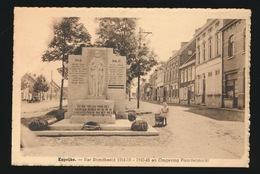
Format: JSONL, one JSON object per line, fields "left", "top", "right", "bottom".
{"left": 20, "top": 100, "right": 245, "bottom": 158}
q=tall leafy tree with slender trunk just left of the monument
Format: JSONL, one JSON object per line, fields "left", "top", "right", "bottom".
{"left": 42, "top": 17, "right": 91, "bottom": 111}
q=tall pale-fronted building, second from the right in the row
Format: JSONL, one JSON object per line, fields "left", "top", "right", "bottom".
{"left": 194, "top": 19, "right": 233, "bottom": 107}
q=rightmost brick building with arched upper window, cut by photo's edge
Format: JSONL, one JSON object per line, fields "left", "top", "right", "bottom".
{"left": 221, "top": 19, "right": 246, "bottom": 108}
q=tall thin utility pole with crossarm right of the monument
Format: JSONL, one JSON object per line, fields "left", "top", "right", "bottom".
{"left": 137, "top": 27, "right": 152, "bottom": 108}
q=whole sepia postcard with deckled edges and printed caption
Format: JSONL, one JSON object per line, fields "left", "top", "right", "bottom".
{"left": 12, "top": 7, "right": 251, "bottom": 167}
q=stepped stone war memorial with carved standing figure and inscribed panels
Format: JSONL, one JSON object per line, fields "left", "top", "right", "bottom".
{"left": 65, "top": 47, "right": 127, "bottom": 124}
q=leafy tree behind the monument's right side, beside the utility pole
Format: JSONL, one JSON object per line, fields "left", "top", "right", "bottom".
{"left": 96, "top": 18, "right": 157, "bottom": 96}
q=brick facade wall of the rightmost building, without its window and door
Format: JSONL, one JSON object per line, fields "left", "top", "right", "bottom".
{"left": 223, "top": 20, "right": 246, "bottom": 108}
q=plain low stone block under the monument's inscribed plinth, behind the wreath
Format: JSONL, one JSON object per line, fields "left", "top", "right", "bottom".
{"left": 70, "top": 114, "right": 116, "bottom": 124}
